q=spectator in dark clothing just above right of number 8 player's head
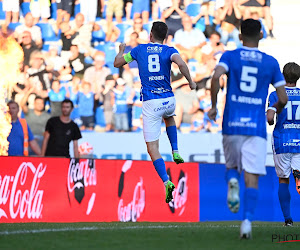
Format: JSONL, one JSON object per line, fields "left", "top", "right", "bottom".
{"left": 159, "top": 0, "right": 186, "bottom": 39}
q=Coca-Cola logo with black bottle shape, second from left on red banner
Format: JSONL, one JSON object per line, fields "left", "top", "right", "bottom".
{"left": 67, "top": 159, "right": 97, "bottom": 215}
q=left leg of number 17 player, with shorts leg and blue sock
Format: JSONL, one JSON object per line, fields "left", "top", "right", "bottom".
{"left": 273, "top": 153, "right": 293, "bottom": 226}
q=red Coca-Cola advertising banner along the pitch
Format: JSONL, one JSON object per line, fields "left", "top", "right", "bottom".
{"left": 0, "top": 157, "right": 199, "bottom": 223}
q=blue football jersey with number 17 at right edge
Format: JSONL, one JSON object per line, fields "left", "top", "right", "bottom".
{"left": 269, "top": 87, "right": 300, "bottom": 154}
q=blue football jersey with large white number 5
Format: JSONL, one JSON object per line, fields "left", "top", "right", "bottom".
{"left": 219, "top": 47, "right": 285, "bottom": 138}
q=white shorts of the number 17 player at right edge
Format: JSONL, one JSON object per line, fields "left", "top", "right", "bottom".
{"left": 273, "top": 153, "right": 300, "bottom": 178}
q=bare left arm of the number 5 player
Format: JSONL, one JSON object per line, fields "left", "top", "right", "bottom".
{"left": 208, "top": 65, "right": 227, "bottom": 121}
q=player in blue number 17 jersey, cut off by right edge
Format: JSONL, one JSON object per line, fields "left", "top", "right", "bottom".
{"left": 267, "top": 63, "right": 300, "bottom": 226}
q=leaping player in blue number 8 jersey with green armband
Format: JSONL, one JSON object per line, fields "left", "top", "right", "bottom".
{"left": 114, "top": 22, "right": 196, "bottom": 203}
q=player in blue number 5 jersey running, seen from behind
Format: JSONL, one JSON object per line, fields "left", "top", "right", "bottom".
{"left": 208, "top": 19, "right": 288, "bottom": 238}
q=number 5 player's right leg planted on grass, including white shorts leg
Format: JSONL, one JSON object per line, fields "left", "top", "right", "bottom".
{"left": 240, "top": 136, "right": 267, "bottom": 239}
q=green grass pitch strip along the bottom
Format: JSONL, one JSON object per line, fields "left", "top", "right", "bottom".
{"left": 0, "top": 222, "right": 300, "bottom": 250}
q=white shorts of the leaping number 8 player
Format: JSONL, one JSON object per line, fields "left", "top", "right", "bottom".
{"left": 143, "top": 96, "right": 176, "bottom": 142}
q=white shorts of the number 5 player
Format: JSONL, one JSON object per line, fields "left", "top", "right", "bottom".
{"left": 223, "top": 135, "right": 267, "bottom": 175}
